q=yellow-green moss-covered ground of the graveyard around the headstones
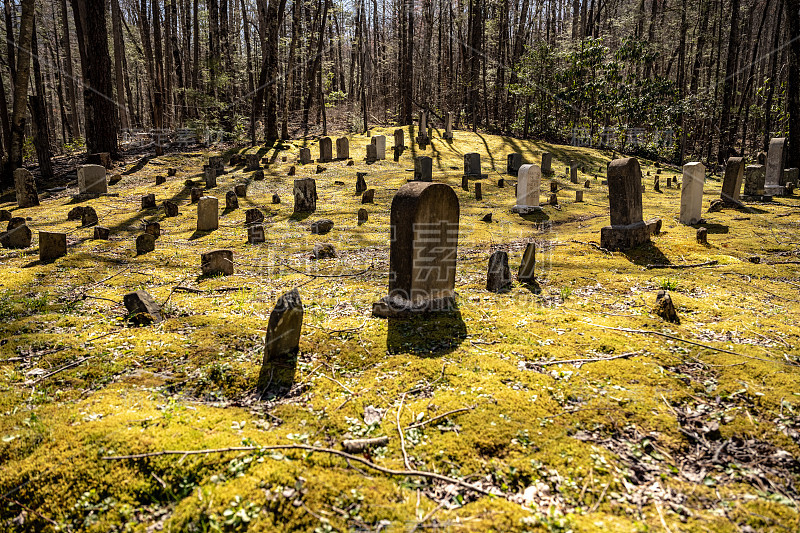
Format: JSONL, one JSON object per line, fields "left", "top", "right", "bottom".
{"left": 0, "top": 128, "right": 800, "bottom": 532}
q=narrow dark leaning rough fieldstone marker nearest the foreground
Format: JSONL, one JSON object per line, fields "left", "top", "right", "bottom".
{"left": 256, "top": 289, "right": 303, "bottom": 394}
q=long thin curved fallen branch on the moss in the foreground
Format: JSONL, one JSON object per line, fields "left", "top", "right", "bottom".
{"left": 101, "top": 444, "right": 500, "bottom": 498}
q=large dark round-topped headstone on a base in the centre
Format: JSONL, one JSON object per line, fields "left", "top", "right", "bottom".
{"left": 372, "top": 181, "right": 459, "bottom": 318}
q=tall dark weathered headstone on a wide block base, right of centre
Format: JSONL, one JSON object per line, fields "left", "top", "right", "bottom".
{"left": 600, "top": 157, "right": 650, "bottom": 250}
